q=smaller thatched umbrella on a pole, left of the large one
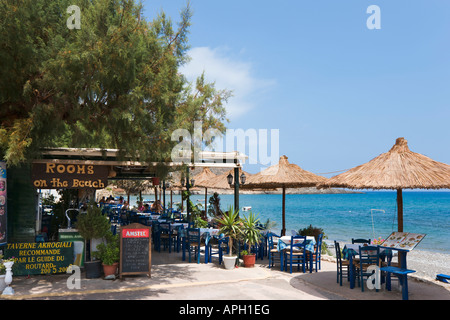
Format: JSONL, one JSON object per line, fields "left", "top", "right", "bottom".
{"left": 242, "top": 156, "right": 327, "bottom": 235}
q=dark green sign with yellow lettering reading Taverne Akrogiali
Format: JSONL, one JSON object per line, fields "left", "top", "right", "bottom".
{"left": 5, "top": 242, "right": 73, "bottom": 276}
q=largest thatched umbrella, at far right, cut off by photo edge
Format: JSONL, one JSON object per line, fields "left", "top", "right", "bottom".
{"left": 319, "top": 138, "right": 450, "bottom": 232}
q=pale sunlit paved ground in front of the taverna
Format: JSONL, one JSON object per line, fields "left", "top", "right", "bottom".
{"left": 0, "top": 252, "right": 450, "bottom": 300}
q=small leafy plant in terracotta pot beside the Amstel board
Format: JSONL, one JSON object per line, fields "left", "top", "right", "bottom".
{"left": 94, "top": 231, "right": 120, "bottom": 277}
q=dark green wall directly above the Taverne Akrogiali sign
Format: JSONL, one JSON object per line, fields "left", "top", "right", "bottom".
{"left": 7, "top": 165, "right": 37, "bottom": 243}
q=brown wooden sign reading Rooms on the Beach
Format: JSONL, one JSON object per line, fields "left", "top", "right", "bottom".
{"left": 31, "top": 163, "right": 108, "bottom": 189}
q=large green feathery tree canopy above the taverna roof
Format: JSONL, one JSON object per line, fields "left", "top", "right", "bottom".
{"left": 0, "top": 0, "right": 231, "bottom": 165}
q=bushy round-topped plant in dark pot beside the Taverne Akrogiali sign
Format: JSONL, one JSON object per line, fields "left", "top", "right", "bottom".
{"left": 76, "top": 203, "right": 111, "bottom": 279}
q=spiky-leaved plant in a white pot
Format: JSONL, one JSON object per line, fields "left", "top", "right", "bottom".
{"left": 216, "top": 207, "right": 241, "bottom": 269}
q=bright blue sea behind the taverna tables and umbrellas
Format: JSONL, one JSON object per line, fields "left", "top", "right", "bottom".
{"left": 132, "top": 191, "right": 450, "bottom": 253}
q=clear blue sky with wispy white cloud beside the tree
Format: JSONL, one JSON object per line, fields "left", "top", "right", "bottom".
{"left": 142, "top": 0, "right": 450, "bottom": 177}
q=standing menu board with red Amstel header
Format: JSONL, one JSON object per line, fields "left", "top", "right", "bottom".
{"left": 119, "top": 223, "right": 152, "bottom": 278}
